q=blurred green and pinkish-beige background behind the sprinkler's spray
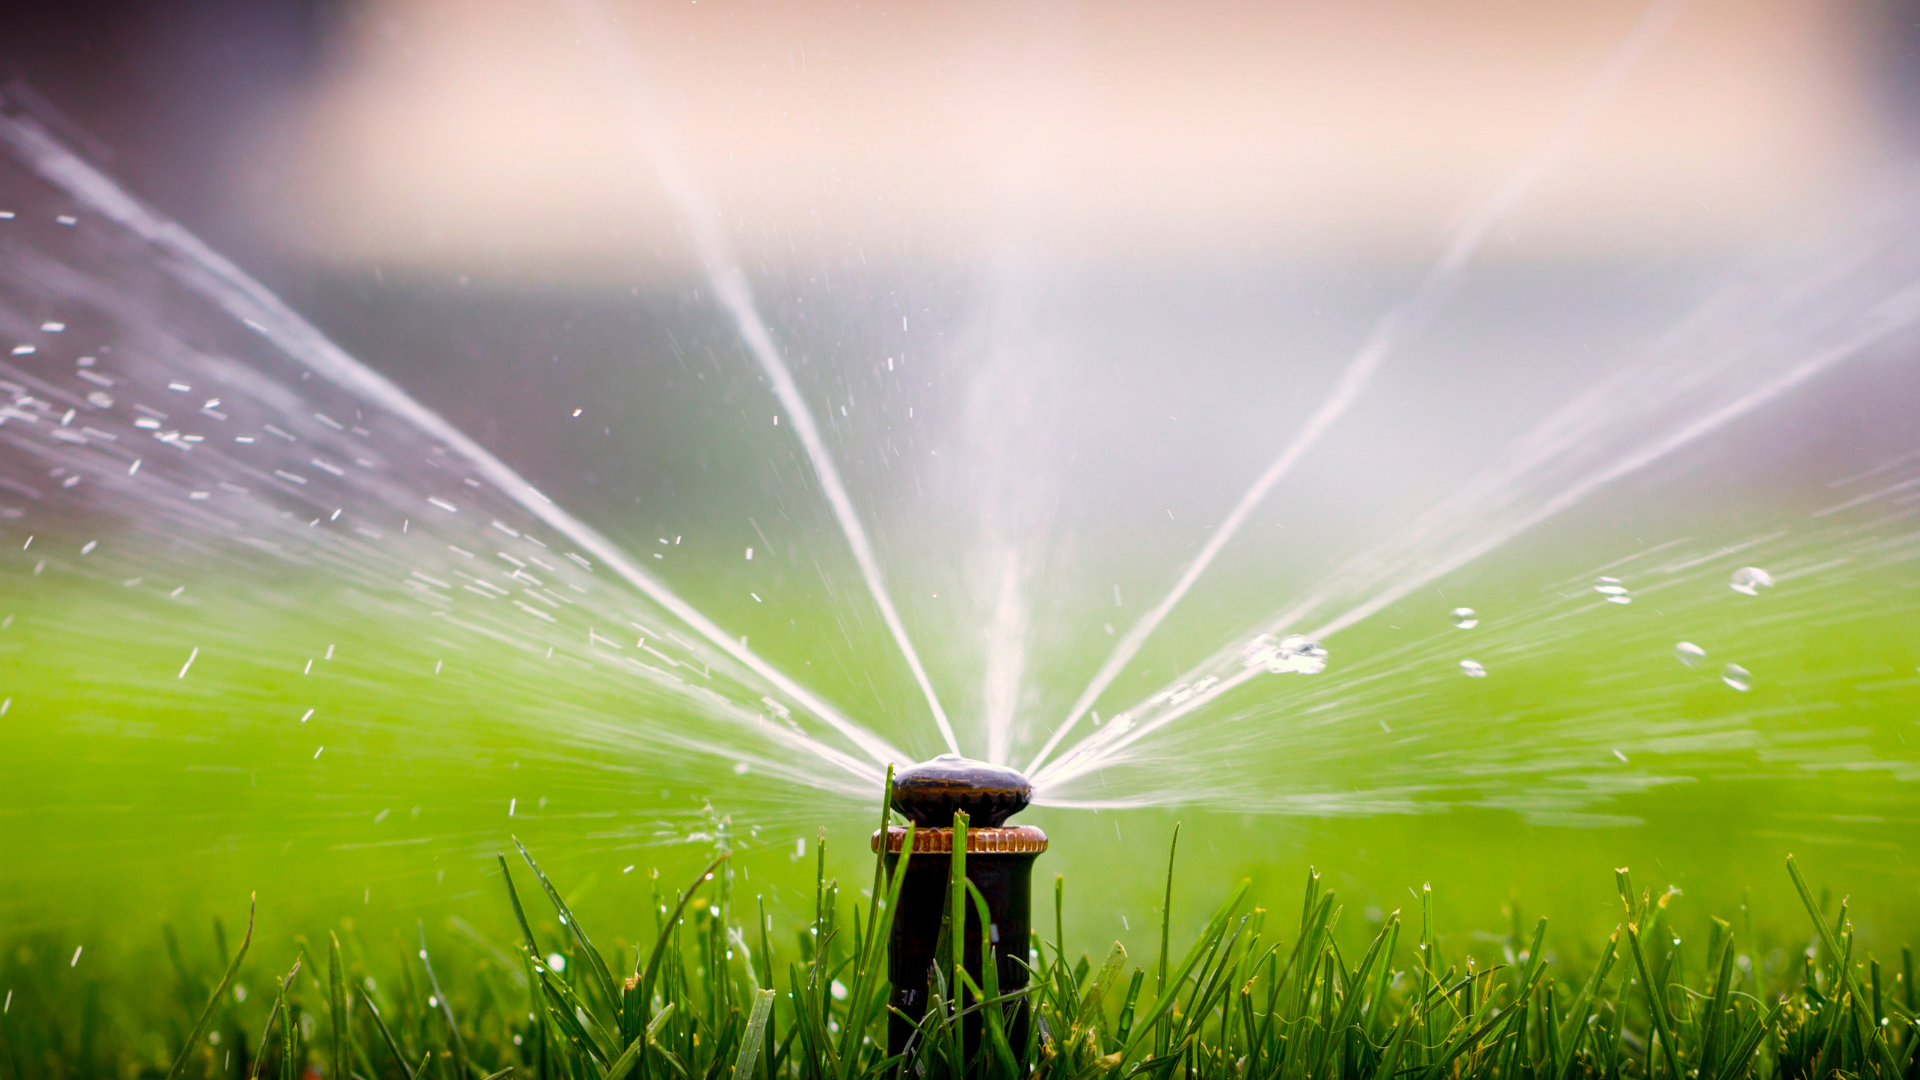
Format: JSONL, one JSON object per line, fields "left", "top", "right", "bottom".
{"left": 0, "top": 0, "right": 1920, "bottom": 968}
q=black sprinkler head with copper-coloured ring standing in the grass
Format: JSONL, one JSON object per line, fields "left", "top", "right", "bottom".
{"left": 874, "top": 753, "right": 1046, "bottom": 1053}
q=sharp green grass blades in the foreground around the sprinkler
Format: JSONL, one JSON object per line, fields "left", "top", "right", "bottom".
{"left": 0, "top": 768, "right": 1920, "bottom": 1080}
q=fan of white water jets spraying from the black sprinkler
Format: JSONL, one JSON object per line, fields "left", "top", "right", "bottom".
{"left": 0, "top": 10, "right": 1920, "bottom": 857}
